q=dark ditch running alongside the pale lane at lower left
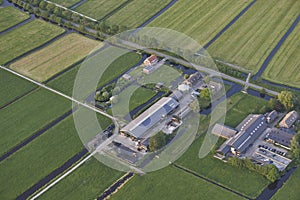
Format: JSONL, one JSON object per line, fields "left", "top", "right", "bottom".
{"left": 17, "top": 149, "right": 88, "bottom": 200}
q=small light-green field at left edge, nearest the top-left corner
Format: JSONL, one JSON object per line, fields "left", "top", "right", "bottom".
{"left": 0, "top": 7, "right": 29, "bottom": 32}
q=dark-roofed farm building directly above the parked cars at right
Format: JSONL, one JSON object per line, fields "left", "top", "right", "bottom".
{"left": 265, "top": 128, "right": 294, "bottom": 149}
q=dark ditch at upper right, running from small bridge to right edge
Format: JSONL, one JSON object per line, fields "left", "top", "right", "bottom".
{"left": 253, "top": 15, "right": 300, "bottom": 80}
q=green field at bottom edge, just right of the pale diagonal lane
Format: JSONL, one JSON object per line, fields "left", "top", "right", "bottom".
{"left": 40, "top": 158, "right": 123, "bottom": 200}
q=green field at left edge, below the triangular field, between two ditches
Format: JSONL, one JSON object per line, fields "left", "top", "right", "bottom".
{"left": 0, "top": 89, "right": 71, "bottom": 155}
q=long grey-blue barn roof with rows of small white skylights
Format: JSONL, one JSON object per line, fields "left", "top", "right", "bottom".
{"left": 231, "top": 115, "right": 267, "bottom": 152}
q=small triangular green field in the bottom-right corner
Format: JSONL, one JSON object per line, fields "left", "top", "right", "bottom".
{"left": 272, "top": 168, "right": 300, "bottom": 200}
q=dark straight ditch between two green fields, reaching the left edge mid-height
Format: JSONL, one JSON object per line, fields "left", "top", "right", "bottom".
{"left": 0, "top": 110, "right": 73, "bottom": 163}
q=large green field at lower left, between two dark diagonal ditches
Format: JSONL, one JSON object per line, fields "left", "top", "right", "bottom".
{"left": 0, "top": 115, "right": 83, "bottom": 199}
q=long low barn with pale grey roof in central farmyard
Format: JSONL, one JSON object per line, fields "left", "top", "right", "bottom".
{"left": 121, "top": 97, "right": 179, "bottom": 138}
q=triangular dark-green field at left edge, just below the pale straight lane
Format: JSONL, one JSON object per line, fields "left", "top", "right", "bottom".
{"left": 0, "top": 70, "right": 36, "bottom": 107}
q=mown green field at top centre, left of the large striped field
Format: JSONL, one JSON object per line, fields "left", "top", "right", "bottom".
{"left": 108, "top": 0, "right": 170, "bottom": 28}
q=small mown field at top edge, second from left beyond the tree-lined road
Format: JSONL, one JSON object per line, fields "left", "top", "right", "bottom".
{"left": 75, "top": 0, "right": 127, "bottom": 20}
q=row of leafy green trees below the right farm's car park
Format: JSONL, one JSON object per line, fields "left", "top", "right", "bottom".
{"left": 228, "top": 156, "right": 280, "bottom": 182}
